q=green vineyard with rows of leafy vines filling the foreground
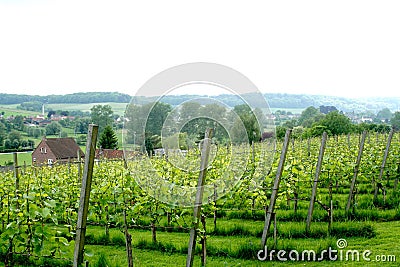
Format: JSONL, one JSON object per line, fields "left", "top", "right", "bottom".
{"left": 0, "top": 132, "right": 400, "bottom": 266}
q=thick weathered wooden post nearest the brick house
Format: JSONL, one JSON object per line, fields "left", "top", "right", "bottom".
{"left": 73, "top": 124, "right": 99, "bottom": 267}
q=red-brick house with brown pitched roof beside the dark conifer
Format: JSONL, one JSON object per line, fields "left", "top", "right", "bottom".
{"left": 32, "top": 137, "right": 85, "bottom": 165}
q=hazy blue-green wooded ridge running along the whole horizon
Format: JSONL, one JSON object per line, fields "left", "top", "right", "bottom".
{"left": 0, "top": 92, "right": 400, "bottom": 113}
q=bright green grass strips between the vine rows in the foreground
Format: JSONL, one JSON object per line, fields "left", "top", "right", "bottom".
{"left": 0, "top": 221, "right": 400, "bottom": 267}
